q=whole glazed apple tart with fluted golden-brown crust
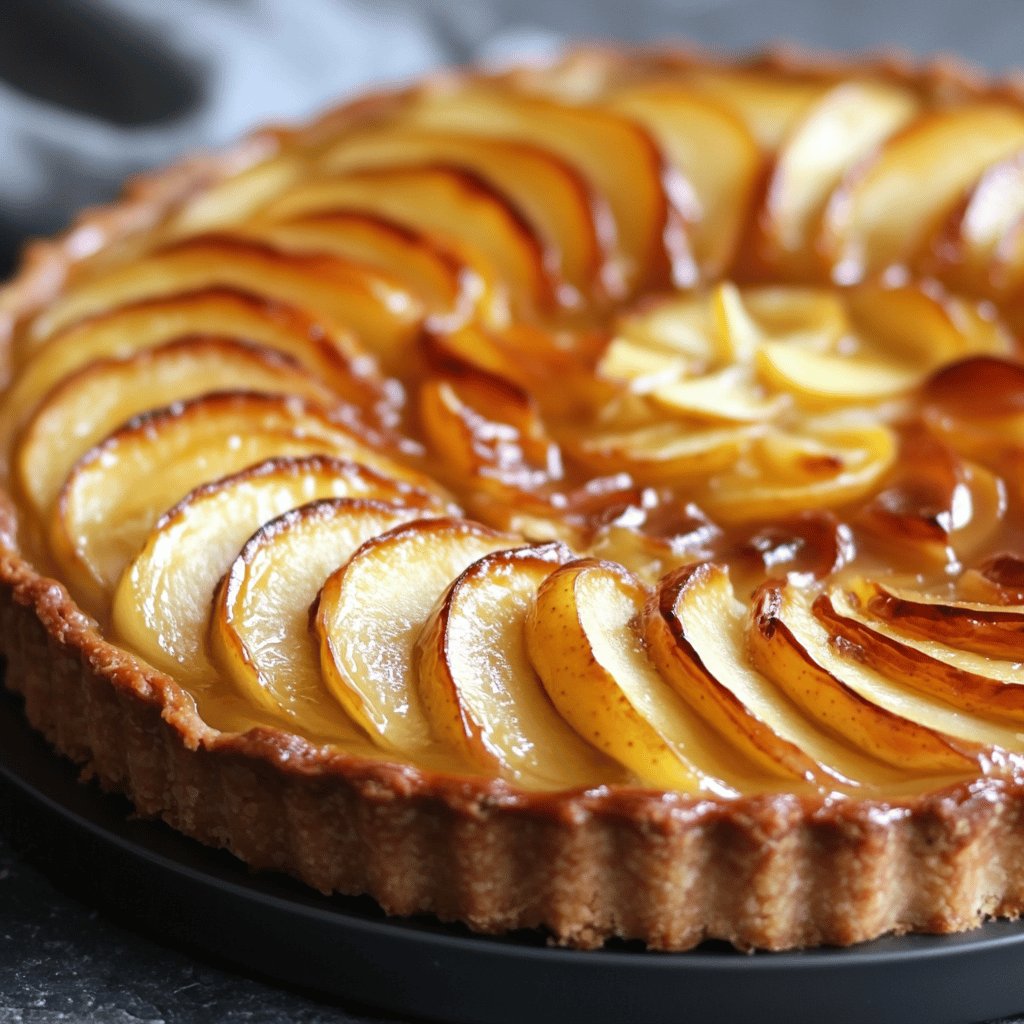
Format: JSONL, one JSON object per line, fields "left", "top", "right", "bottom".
{"left": 9, "top": 50, "right": 1024, "bottom": 949}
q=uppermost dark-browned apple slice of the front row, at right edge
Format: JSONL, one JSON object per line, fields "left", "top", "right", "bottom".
{"left": 844, "top": 580, "right": 1024, "bottom": 663}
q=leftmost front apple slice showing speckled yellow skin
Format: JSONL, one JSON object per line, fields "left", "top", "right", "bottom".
{"left": 526, "top": 560, "right": 764, "bottom": 797}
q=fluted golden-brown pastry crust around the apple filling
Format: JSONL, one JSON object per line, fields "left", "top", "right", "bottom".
{"left": 6, "top": 48, "right": 1024, "bottom": 950}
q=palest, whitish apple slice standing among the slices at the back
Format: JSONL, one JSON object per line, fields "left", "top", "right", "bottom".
{"left": 761, "top": 81, "right": 919, "bottom": 267}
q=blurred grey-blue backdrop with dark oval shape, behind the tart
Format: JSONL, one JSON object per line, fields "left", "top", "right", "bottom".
{"left": 6, "top": 0, "right": 1024, "bottom": 273}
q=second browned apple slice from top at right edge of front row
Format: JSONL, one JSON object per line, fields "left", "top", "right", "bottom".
{"left": 814, "top": 587, "right": 1024, "bottom": 729}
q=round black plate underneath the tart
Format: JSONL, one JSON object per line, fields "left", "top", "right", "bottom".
{"left": 0, "top": 692, "right": 1024, "bottom": 1024}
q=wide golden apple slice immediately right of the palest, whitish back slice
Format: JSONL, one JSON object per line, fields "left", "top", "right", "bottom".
{"left": 821, "top": 102, "right": 1024, "bottom": 282}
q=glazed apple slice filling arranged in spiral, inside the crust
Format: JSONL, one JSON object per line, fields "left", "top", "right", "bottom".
{"left": 9, "top": 48, "right": 1024, "bottom": 800}
